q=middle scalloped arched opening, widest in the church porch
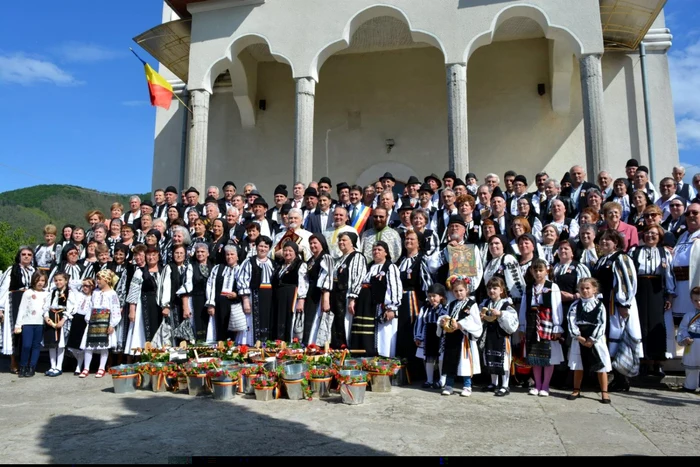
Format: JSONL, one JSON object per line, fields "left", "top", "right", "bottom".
{"left": 313, "top": 7, "right": 447, "bottom": 185}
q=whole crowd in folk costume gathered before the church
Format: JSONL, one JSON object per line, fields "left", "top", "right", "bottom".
{"left": 0, "top": 159, "right": 700, "bottom": 403}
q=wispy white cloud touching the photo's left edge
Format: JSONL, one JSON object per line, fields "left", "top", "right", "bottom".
{"left": 0, "top": 52, "right": 84, "bottom": 86}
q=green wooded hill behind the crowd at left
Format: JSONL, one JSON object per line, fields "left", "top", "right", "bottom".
{"left": 0, "top": 185, "right": 151, "bottom": 270}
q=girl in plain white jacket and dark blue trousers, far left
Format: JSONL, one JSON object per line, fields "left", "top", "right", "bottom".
{"left": 15, "top": 271, "right": 48, "bottom": 377}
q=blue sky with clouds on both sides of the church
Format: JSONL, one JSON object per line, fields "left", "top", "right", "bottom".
{"left": 0, "top": 0, "right": 700, "bottom": 193}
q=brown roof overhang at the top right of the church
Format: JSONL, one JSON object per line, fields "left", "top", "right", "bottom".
{"left": 600, "top": 0, "right": 667, "bottom": 51}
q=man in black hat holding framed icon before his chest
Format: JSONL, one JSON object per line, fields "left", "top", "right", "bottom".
{"left": 428, "top": 216, "right": 484, "bottom": 300}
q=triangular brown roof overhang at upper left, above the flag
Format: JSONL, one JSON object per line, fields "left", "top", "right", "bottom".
{"left": 134, "top": 18, "right": 192, "bottom": 83}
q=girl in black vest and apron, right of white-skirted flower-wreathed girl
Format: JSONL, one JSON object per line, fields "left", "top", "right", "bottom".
{"left": 481, "top": 276, "right": 519, "bottom": 397}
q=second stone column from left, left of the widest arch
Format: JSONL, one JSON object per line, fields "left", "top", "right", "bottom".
{"left": 294, "top": 77, "right": 316, "bottom": 185}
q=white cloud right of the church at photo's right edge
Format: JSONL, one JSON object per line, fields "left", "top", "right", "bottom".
{"left": 669, "top": 41, "right": 700, "bottom": 150}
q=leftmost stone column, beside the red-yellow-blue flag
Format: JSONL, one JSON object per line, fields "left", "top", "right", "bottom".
{"left": 184, "top": 89, "right": 210, "bottom": 196}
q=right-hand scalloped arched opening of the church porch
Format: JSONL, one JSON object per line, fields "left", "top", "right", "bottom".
{"left": 467, "top": 8, "right": 585, "bottom": 189}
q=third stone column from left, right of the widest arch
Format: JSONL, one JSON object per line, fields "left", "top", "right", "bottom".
{"left": 447, "top": 63, "right": 469, "bottom": 177}
